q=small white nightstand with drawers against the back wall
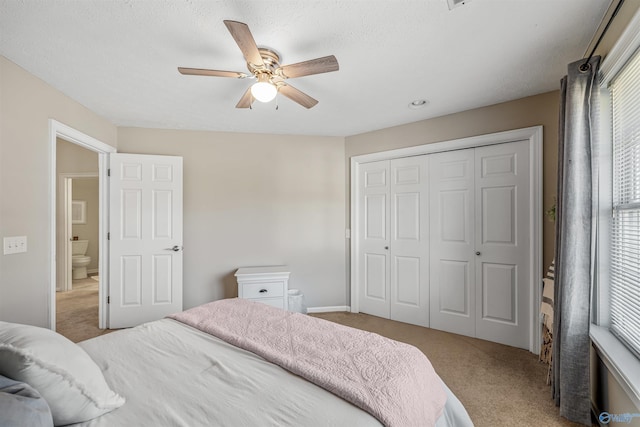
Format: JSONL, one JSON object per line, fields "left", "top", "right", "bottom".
{"left": 235, "top": 265, "right": 291, "bottom": 310}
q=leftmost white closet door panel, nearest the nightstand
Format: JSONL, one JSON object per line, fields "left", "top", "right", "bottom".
{"left": 358, "top": 160, "right": 390, "bottom": 319}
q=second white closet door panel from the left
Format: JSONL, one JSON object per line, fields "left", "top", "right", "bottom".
{"left": 390, "top": 156, "right": 429, "bottom": 326}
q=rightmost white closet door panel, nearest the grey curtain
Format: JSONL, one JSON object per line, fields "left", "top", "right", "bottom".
{"left": 475, "top": 141, "right": 532, "bottom": 348}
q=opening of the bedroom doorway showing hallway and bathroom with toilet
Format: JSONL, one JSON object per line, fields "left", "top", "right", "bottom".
{"left": 56, "top": 138, "right": 104, "bottom": 342}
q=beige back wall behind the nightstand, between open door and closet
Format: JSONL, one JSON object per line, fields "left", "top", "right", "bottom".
{"left": 118, "top": 128, "right": 348, "bottom": 308}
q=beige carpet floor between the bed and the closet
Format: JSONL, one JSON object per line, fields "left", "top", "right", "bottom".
{"left": 313, "top": 313, "right": 579, "bottom": 427}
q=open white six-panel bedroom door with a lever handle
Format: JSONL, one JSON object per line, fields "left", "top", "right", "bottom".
{"left": 108, "top": 153, "right": 182, "bottom": 329}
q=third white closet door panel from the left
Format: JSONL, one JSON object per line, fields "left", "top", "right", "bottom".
{"left": 429, "top": 149, "right": 476, "bottom": 336}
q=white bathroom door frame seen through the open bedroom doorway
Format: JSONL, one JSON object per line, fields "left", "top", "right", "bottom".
{"left": 56, "top": 172, "right": 100, "bottom": 291}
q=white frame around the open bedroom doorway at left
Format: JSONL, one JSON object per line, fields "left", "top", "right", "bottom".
{"left": 48, "top": 119, "right": 116, "bottom": 331}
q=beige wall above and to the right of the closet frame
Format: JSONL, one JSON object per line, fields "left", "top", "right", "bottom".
{"left": 345, "top": 91, "right": 560, "bottom": 271}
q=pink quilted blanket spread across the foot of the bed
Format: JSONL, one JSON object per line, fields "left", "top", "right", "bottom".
{"left": 169, "top": 298, "right": 446, "bottom": 427}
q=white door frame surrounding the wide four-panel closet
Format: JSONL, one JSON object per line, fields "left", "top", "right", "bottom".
{"left": 350, "top": 126, "right": 543, "bottom": 353}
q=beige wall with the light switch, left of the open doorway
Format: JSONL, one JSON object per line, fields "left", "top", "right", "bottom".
{"left": 0, "top": 56, "right": 117, "bottom": 326}
